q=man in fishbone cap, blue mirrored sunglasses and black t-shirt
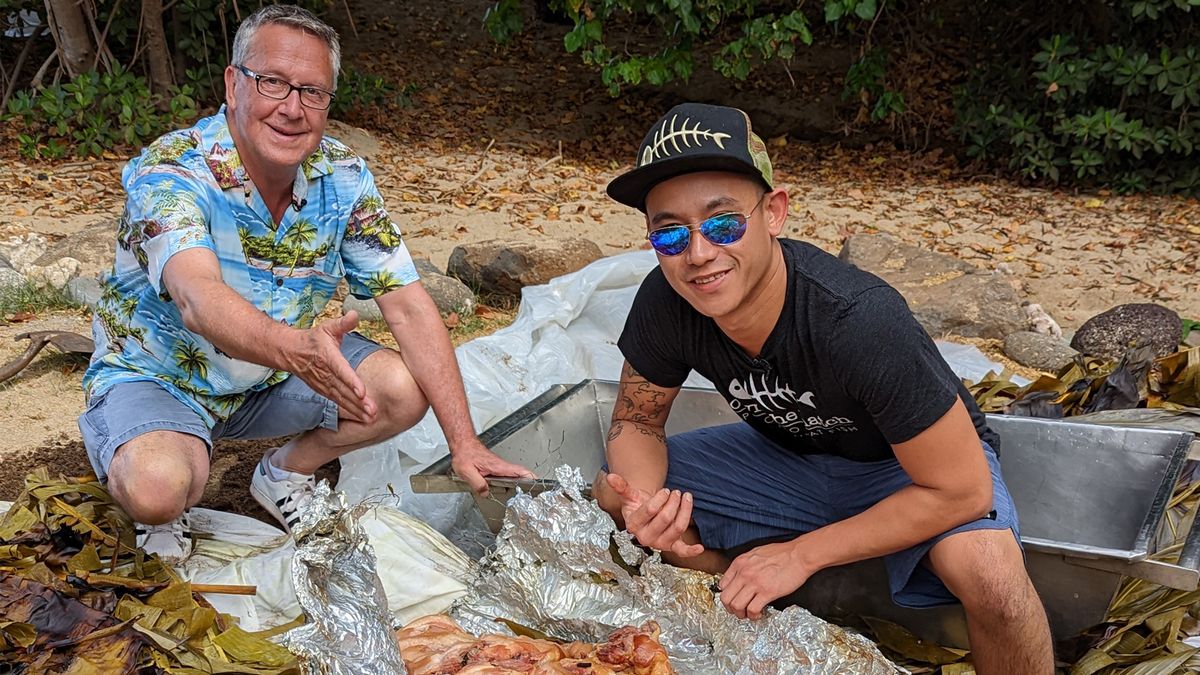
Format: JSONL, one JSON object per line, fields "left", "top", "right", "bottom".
{"left": 594, "top": 103, "right": 1054, "bottom": 674}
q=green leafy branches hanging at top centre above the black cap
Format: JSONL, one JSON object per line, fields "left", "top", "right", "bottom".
{"left": 484, "top": 0, "right": 904, "bottom": 114}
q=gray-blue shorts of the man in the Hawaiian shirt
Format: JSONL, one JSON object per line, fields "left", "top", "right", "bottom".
{"left": 79, "top": 333, "right": 384, "bottom": 482}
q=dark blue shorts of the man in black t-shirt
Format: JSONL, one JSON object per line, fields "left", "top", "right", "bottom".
{"left": 643, "top": 423, "right": 1021, "bottom": 608}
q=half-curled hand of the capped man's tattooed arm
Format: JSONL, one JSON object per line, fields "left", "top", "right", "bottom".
{"left": 605, "top": 473, "right": 704, "bottom": 557}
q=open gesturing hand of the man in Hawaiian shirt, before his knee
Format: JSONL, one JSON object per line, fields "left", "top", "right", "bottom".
{"left": 288, "top": 311, "right": 377, "bottom": 424}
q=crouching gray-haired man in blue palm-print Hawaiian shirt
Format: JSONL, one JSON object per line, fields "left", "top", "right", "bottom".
{"left": 79, "top": 5, "right": 532, "bottom": 562}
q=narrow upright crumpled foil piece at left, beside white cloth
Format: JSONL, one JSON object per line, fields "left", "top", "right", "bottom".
{"left": 283, "top": 480, "right": 407, "bottom": 675}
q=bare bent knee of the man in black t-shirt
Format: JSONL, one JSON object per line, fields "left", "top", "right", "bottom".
{"left": 930, "top": 530, "right": 1039, "bottom": 621}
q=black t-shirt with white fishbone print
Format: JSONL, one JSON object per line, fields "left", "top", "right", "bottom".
{"left": 618, "top": 239, "right": 1000, "bottom": 461}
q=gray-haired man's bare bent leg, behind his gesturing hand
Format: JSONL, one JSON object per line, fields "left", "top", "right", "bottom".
{"left": 271, "top": 350, "right": 430, "bottom": 473}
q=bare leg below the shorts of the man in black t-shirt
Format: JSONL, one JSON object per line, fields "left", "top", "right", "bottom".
{"left": 928, "top": 530, "right": 1054, "bottom": 675}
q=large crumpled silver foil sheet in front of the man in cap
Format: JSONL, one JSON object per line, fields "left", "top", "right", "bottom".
{"left": 450, "top": 466, "right": 904, "bottom": 675}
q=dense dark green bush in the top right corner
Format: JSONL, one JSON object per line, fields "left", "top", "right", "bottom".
{"left": 956, "top": 0, "right": 1200, "bottom": 195}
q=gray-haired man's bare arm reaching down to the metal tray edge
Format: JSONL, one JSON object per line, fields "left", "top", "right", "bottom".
{"left": 376, "top": 282, "right": 534, "bottom": 495}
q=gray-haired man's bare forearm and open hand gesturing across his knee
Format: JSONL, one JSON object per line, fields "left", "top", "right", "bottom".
{"left": 162, "top": 249, "right": 376, "bottom": 422}
